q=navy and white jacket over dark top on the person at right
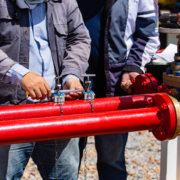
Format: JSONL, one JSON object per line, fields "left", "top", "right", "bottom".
{"left": 77, "top": 0, "right": 160, "bottom": 97}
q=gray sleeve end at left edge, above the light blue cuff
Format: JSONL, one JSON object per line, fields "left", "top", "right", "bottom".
{"left": 0, "top": 49, "right": 17, "bottom": 82}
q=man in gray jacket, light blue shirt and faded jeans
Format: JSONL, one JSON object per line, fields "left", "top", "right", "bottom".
{"left": 0, "top": 0, "right": 90, "bottom": 180}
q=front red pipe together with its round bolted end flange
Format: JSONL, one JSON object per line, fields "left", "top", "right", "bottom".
{"left": 0, "top": 94, "right": 179, "bottom": 145}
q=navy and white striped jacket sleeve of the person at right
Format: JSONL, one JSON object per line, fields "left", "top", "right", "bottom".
{"left": 124, "top": 0, "right": 160, "bottom": 73}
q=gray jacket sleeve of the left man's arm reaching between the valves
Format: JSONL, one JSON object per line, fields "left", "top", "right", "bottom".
{"left": 61, "top": 0, "right": 91, "bottom": 81}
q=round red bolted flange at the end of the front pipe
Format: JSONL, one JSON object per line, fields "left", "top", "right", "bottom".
{"left": 152, "top": 93, "right": 177, "bottom": 141}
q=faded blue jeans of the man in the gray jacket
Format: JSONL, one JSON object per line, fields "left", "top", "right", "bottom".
{"left": 0, "top": 138, "right": 79, "bottom": 180}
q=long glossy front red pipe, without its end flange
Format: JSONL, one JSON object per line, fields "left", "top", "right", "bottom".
{"left": 0, "top": 107, "right": 161, "bottom": 145}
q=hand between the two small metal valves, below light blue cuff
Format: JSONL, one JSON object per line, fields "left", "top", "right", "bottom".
{"left": 63, "top": 78, "right": 83, "bottom": 100}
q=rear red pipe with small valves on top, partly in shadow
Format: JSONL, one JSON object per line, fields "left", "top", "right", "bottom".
{"left": 0, "top": 94, "right": 155, "bottom": 121}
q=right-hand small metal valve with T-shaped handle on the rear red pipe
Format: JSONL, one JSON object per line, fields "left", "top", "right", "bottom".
{"left": 81, "top": 74, "right": 96, "bottom": 101}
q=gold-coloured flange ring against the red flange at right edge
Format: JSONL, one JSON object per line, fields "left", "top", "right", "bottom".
{"left": 167, "top": 95, "right": 180, "bottom": 139}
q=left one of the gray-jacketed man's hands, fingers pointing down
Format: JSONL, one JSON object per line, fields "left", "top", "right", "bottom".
{"left": 21, "top": 72, "right": 51, "bottom": 100}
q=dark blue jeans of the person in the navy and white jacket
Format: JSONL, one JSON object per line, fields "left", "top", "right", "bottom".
{"left": 79, "top": 133, "right": 128, "bottom": 180}
